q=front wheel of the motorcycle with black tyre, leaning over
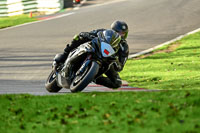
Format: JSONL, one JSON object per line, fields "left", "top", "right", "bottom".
{"left": 70, "top": 61, "right": 99, "bottom": 92}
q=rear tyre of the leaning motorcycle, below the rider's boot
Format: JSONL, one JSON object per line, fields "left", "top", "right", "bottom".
{"left": 45, "top": 71, "right": 62, "bottom": 92}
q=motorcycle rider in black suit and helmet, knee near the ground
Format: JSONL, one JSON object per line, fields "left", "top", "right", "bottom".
{"left": 54, "top": 21, "right": 129, "bottom": 88}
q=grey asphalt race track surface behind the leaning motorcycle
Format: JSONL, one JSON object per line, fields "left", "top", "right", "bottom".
{"left": 0, "top": 0, "right": 200, "bottom": 95}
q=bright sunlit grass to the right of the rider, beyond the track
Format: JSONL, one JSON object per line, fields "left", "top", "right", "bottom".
{"left": 120, "top": 33, "right": 200, "bottom": 90}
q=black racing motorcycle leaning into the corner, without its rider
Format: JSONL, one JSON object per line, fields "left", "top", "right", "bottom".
{"left": 45, "top": 30, "right": 121, "bottom": 92}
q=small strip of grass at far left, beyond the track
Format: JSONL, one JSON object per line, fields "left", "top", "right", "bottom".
{"left": 0, "top": 15, "right": 37, "bottom": 29}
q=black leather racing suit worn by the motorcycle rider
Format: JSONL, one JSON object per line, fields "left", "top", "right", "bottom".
{"left": 55, "top": 29, "right": 129, "bottom": 88}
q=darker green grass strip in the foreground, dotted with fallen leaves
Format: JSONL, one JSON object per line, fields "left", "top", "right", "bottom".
{"left": 0, "top": 90, "right": 200, "bottom": 133}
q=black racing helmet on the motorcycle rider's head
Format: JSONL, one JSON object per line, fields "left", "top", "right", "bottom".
{"left": 111, "top": 21, "right": 128, "bottom": 39}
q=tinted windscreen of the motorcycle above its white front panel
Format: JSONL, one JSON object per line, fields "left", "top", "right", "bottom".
{"left": 98, "top": 30, "right": 121, "bottom": 51}
